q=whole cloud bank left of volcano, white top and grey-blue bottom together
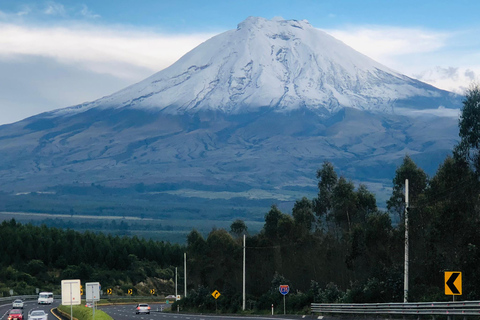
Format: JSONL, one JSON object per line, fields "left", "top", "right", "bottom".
{"left": 0, "top": 19, "right": 214, "bottom": 125}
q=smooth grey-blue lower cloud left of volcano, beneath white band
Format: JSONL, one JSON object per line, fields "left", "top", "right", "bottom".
{"left": 0, "top": 56, "right": 131, "bottom": 124}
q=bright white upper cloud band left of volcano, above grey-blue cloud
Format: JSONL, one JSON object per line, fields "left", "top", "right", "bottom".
{"left": 0, "top": 24, "right": 213, "bottom": 80}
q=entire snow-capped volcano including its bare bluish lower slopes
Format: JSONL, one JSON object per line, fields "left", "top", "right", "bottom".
{"left": 0, "top": 17, "right": 461, "bottom": 205}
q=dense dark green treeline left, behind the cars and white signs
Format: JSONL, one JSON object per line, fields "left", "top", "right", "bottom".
{"left": 0, "top": 219, "right": 184, "bottom": 295}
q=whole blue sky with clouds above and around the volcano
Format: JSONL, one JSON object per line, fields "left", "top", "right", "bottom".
{"left": 0, "top": 0, "right": 480, "bottom": 125}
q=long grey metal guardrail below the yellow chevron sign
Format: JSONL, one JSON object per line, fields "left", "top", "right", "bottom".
{"left": 311, "top": 301, "right": 480, "bottom": 319}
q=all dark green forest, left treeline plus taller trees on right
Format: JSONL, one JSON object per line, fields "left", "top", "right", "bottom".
{"left": 0, "top": 86, "right": 480, "bottom": 312}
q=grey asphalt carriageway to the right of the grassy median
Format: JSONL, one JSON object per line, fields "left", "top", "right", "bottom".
{"left": 98, "top": 304, "right": 316, "bottom": 320}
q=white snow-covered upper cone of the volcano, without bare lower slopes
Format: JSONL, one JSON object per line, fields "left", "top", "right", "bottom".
{"left": 60, "top": 17, "right": 454, "bottom": 114}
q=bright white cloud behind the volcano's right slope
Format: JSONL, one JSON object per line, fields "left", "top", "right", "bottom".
{"left": 325, "top": 26, "right": 480, "bottom": 94}
